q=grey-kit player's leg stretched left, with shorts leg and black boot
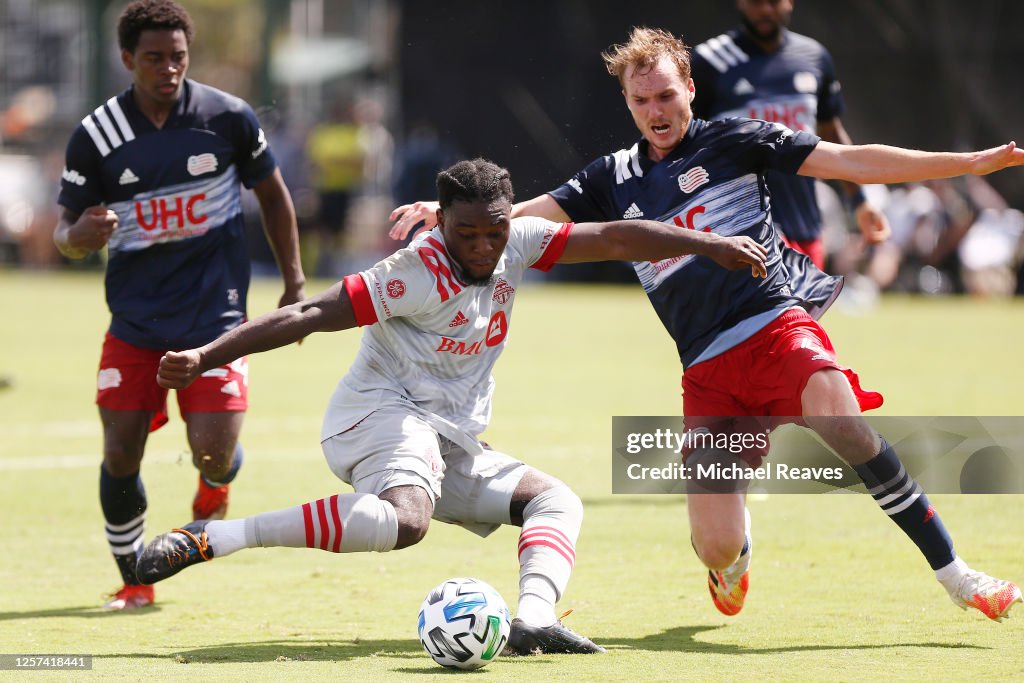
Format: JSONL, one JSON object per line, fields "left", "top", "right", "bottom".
{"left": 132, "top": 411, "right": 442, "bottom": 584}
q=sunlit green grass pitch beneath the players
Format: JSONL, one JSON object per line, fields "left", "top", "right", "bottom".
{"left": 0, "top": 271, "right": 1024, "bottom": 683}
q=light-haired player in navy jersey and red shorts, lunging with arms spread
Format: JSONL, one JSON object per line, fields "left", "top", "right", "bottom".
{"left": 392, "top": 28, "right": 1024, "bottom": 621}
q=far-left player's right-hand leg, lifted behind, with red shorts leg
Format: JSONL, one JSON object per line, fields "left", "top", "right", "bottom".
{"left": 178, "top": 357, "right": 249, "bottom": 519}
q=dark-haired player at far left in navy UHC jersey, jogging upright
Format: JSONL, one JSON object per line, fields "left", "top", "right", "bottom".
{"left": 54, "top": 0, "right": 305, "bottom": 609}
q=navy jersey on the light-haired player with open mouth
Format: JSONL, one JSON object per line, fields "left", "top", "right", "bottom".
{"left": 550, "top": 119, "right": 842, "bottom": 367}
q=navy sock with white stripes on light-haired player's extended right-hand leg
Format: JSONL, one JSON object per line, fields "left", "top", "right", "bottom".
{"left": 853, "top": 439, "right": 956, "bottom": 569}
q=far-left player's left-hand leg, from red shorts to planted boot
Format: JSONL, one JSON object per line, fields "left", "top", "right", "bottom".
{"left": 96, "top": 334, "right": 167, "bottom": 609}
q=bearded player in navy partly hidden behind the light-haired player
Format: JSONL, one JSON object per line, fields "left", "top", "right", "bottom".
{"left": 692, "top": 0, "right": 890, "bottom": 268}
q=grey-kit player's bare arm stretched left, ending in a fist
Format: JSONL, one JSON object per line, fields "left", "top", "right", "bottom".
{"left": 157, "top": 283, "right": 355, "bottom": 389}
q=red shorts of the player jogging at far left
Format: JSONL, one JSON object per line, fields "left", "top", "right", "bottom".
{"left": 96, "top": 333, "right": 249, "bottom": 431}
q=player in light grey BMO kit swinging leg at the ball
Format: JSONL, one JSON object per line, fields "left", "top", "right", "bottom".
{"left": 138, "top": 159, "right": 766, "bottom": 654}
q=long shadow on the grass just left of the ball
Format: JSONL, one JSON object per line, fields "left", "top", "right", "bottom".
{"left": 100, "top": 638, "right": 428, "bottom": 669}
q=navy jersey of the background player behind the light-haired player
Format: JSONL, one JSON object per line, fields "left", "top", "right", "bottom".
{"left": 692, "top": 29, "right": 843, "bottom": 242}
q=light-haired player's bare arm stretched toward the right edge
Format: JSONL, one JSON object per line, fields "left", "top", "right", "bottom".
{"left": 797, "top": 140, "right": 1024, "bottom": 183}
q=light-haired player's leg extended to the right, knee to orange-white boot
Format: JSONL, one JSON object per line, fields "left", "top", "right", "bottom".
{"left": 801, "top": 369, "right": 1024, "bottom": 621}
